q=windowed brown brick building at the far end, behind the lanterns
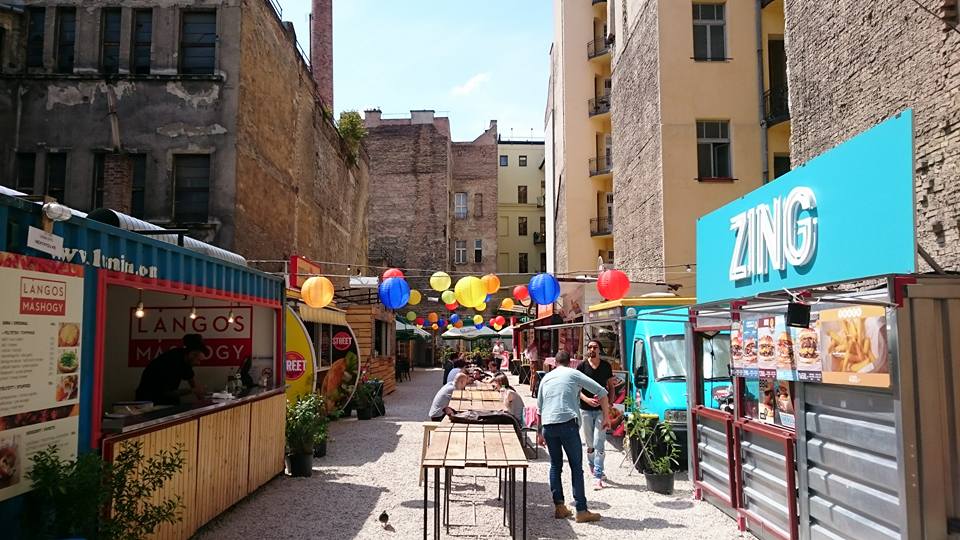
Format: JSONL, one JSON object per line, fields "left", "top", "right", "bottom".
{"left": 364, "top": 110, "right": 497, "bottom": 280}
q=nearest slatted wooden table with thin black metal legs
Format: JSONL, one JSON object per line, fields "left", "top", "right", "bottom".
{"left": 422, "top": 424, "right": 529, "bottom": 539}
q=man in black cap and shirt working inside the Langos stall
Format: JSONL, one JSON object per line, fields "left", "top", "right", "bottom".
{"left": 137, "top": 334, "right": 206, "bottom": 405}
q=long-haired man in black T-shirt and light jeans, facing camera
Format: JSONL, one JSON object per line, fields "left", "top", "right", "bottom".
{"left": 577, "top": 339, "right": 613, "bottom": 489}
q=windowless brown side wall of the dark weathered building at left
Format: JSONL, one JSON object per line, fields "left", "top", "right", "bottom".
{"left": 235, "top": 0, "right": 369, "bottom": 274}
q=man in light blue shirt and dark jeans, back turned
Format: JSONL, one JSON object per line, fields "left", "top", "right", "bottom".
{"left": 537, "top": 351, "right": 610, "bottom": 523}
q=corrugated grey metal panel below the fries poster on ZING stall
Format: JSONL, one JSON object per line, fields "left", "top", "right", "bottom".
{"left": 798, "top": 384, "right": 903, "bottom": 540}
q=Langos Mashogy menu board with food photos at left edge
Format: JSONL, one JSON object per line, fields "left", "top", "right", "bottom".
{"left": 0, "top": 253, "right": 83, "bottom": 501}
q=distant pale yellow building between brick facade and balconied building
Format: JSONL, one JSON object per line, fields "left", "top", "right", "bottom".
{"left": 497, "top": 139, "right": 547, "bottom": 284}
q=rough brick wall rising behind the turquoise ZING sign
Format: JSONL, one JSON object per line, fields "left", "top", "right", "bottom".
{"left": 785, "top": 0, "right": 960, "bottom": 270}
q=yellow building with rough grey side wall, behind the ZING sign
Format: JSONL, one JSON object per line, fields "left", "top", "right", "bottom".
{"left": 607, "top": 0, "right": 790, "bottom": 295}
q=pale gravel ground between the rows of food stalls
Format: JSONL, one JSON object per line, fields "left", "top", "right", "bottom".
{"left": 197, "top": 369, "right": 752, "bottom": 540}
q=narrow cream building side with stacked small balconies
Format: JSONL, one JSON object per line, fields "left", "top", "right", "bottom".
{"left": 545, "top": 0, "right": 615, "bottom": 274}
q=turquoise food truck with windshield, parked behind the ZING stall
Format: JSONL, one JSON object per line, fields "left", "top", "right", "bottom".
{"left": 587, "top": 294, "right": 731, "bottom": 450}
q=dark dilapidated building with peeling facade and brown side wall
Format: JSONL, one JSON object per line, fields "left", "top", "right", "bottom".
{"left": 0, "top": 0, "right": 368, "bottom": 274}
